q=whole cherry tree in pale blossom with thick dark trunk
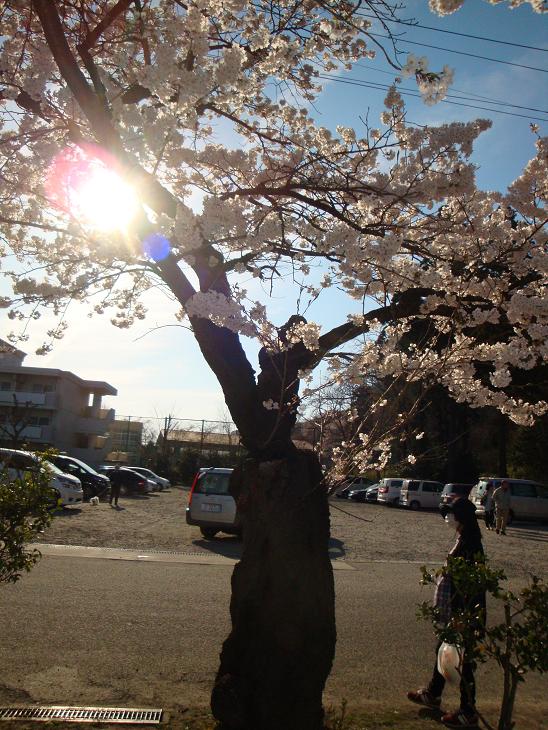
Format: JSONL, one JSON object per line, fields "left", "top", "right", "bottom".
{"left": 0, "top": 0, "right": 548, "bottom": 730}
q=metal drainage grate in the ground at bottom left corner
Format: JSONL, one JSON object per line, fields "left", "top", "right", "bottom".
{"left": 0, "top": 705, "right": 162, "bottom": 725}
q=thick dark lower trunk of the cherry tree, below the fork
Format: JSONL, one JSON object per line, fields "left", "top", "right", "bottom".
{"left": 211, "top": 450, "right": 336, "bottom": 730}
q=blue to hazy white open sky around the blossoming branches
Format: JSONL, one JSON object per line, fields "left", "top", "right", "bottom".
{"left": 4, "top": 0, "right": 548, "bottom": 420}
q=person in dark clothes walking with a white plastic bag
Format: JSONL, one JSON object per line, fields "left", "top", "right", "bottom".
{"left": 407, "top": 497, "right": 485, "bottom": 728}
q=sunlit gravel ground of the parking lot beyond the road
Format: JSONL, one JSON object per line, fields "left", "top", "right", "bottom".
{"left": 39, "top": 487, "right": 548, "bottom": 577}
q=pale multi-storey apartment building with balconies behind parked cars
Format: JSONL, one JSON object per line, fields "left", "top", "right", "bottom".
{"left": 0, "top": 339, "right": 117, "bottom": 465}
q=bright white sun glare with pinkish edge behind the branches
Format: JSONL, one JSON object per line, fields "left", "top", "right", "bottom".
{"left": 46, "top": 145, "right": 139, "bottom": 231}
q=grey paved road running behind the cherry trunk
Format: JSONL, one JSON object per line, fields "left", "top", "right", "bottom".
{"left": 0, "top": 549, "right": 548, "bottom": 727}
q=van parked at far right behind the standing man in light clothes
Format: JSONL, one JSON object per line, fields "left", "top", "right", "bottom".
{"left": 471, "top": 477, "right": 548, "bottom": 524}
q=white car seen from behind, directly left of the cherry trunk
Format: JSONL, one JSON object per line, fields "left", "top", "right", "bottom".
{"left": 186, "top": 467, "right": 242, "bottom": 539}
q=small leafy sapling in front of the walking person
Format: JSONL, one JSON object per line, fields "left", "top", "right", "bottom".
{"left": 419, "top": 558, "right": 548, "bottom": 730}
